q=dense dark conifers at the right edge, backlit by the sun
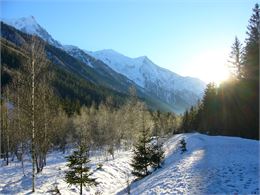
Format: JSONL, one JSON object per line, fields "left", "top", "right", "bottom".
{"left": 180, "top": 4, "right": 260, "bottom": 139}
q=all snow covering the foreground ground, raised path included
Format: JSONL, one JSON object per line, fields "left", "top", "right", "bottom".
{"left": 0, "top": 133, "right": 260, "bottom": 195}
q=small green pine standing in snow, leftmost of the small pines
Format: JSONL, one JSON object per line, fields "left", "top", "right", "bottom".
{"left": 65, "top": 146, "right": 97, "bottom": 194}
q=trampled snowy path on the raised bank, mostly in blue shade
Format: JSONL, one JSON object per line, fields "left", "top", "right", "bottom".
{"left": 125, "top": 134, "right": 260, "bottom": 194}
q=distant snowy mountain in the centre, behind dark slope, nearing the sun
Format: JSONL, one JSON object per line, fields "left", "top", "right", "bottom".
{"left": 88, "top": 49, "right": 206, "bottom": 104}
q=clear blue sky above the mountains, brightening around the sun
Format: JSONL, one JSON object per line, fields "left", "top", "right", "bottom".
{"left": 1, "top": 0, "right": 257, "bottom": 82}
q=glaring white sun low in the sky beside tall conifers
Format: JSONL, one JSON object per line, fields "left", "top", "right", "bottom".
{"left": 187, "top": 50, "right": 230, "bottom": 85}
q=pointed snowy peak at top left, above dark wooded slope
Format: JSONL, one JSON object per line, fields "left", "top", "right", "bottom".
{"left": 1, "top": 16, "right": 62, "bottom": 48}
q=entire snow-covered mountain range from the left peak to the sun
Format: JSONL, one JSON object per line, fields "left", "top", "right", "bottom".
{"left": 3, "top": 16, "right": 206, "bottom": 113}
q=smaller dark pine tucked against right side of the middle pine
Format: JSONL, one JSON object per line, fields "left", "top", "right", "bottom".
{"left": 150, "top": 137, "right": 164, "bottom": 169}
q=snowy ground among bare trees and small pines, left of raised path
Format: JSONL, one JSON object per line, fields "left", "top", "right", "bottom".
{"left": 0, "top": 151, "right": 132, "bottom": 195}
